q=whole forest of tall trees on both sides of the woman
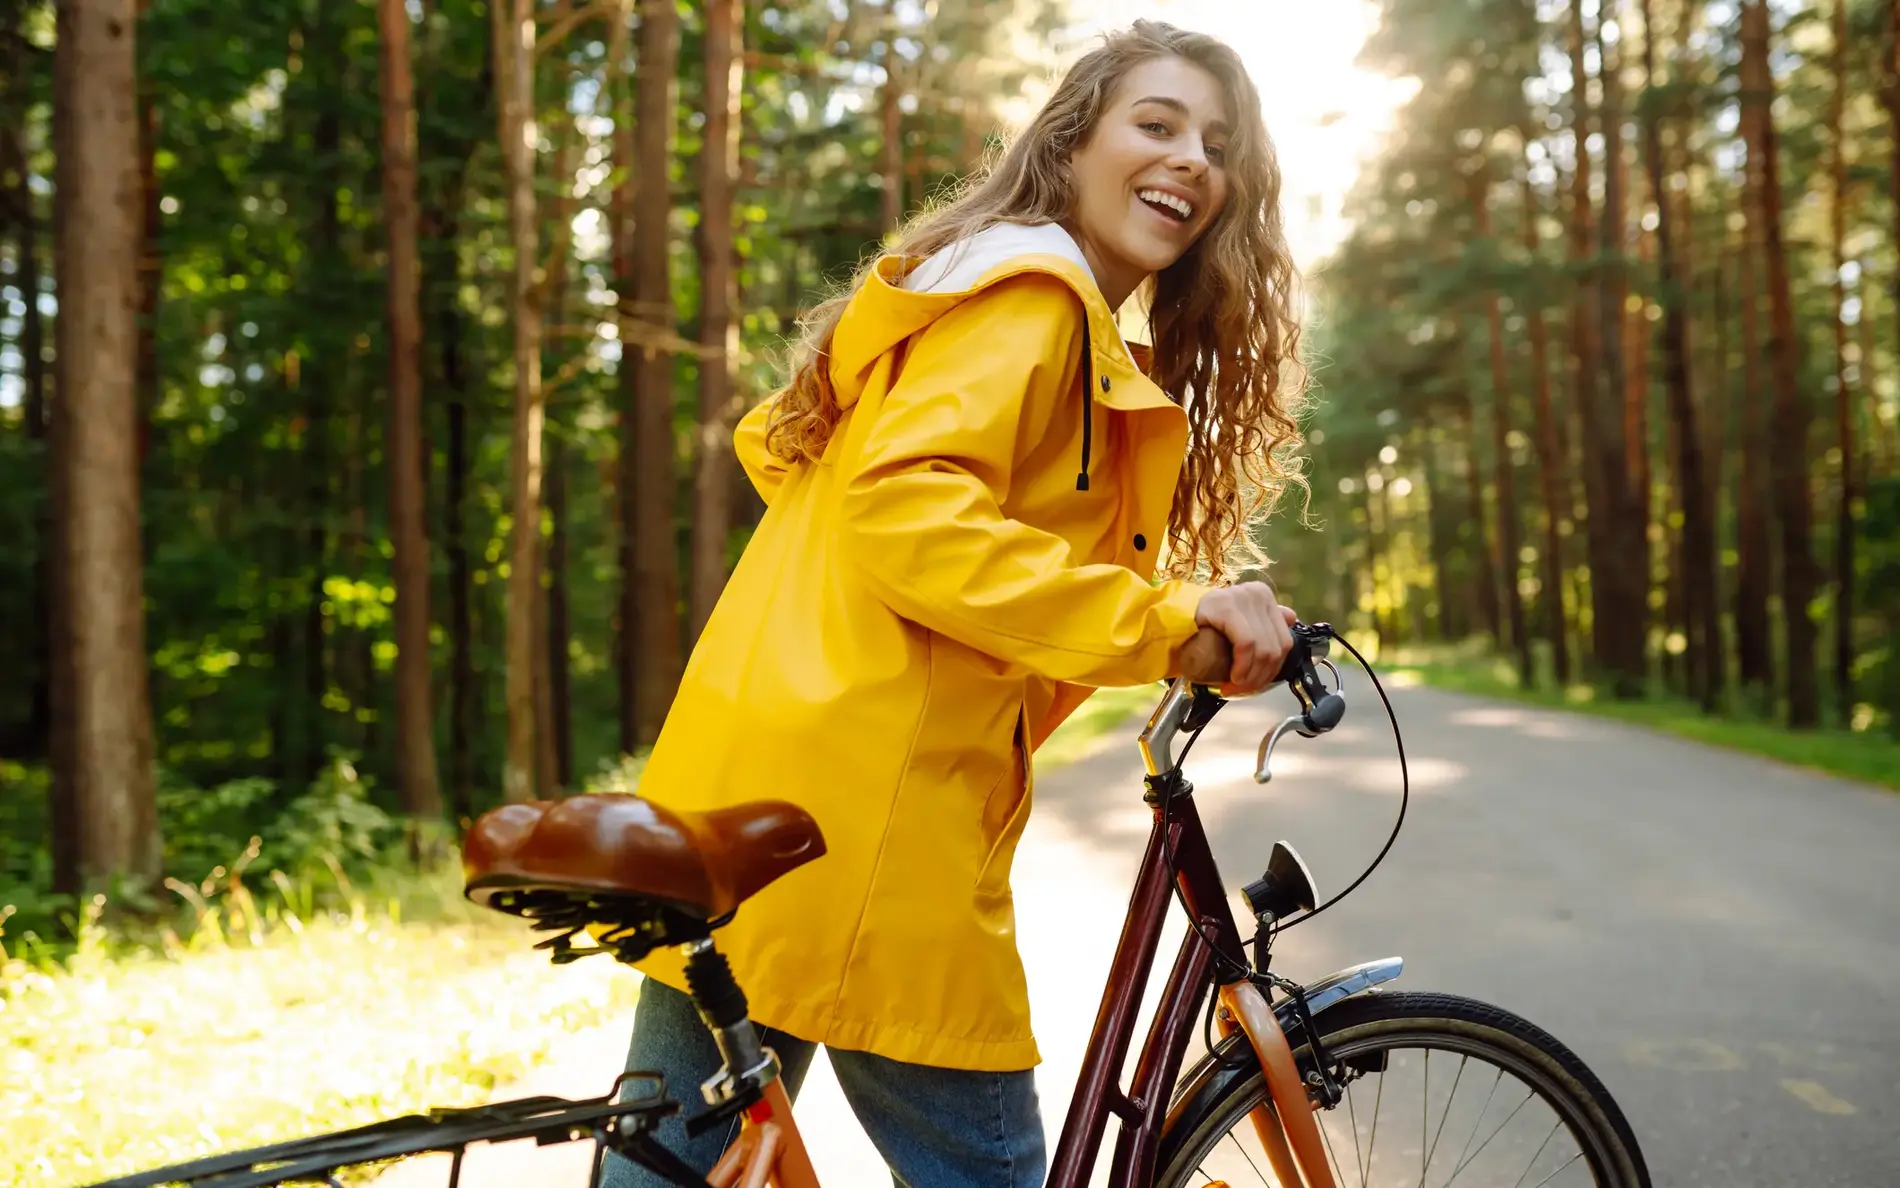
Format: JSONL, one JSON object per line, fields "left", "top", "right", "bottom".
{"left": 0, "top": 0, "right": 1900, "bottom": 943}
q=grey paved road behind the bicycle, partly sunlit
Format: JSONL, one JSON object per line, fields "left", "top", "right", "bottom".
{"left": 386, "top": 679, "right": 1900, "bottom": 1188}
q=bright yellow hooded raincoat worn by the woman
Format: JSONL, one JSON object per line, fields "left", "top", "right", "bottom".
{"left": 640, "top": 226, "right": 1205, "bottom": 1070}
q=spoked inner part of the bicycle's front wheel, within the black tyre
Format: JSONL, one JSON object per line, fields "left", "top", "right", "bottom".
{"left": 1174, "top": 1025, "right": 1617, "bottom": 1188}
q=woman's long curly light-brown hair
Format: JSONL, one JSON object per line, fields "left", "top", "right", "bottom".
{"left": 766, "top": 21, "right": 1309, "bottom": 582}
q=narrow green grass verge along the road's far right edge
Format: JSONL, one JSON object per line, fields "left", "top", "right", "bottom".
{"left": 1379, "top": 644, "right": 1900, "bottom": 791}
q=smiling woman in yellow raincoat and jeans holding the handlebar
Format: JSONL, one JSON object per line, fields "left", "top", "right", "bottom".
{"left": 608, "top": 23, "right": 1302, "bottom": 1188}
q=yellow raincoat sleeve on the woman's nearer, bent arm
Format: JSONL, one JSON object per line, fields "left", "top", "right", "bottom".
{"left": 838, "top": 274, "right": 1205, "bottom": 686}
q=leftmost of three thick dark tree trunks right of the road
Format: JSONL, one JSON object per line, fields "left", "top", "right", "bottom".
{"left": 1590, "top": 0, "right": 1649, "bottom": 698}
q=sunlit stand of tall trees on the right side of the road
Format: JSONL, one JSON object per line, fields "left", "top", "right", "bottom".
{"left": 1277, "top": 0, "right": 1900, "bottom": 732}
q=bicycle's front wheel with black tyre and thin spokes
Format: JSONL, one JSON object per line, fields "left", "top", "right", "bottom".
{"left": 1155, "top": 994, "right": 1649, "bottom": 1188}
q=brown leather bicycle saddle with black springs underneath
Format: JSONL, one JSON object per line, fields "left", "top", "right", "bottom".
{"left": 462, "top": 793, "right": 825, "bottom": 960}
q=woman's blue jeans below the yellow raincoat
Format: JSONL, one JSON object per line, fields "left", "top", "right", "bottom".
{"left": 600, "top": 979, "right": 1045, "bottom": 1188}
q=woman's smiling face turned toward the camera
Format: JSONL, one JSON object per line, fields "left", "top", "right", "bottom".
{"left": 1066, "top": 57, "right": 1233, "bottom": 308}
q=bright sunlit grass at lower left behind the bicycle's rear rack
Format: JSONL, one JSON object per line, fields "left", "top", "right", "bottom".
{"left": 0, "top": 869, "right": 638, "bottom": 1188}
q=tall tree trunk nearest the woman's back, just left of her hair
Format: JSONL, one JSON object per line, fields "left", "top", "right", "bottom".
{"left": 692, "top": 0, "right": 745, "bottom": 639}
